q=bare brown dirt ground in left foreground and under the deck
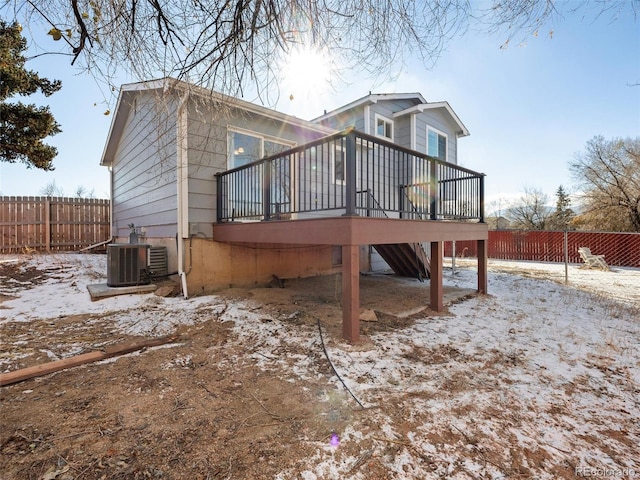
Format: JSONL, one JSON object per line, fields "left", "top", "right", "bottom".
{"left": 0, "top": 264, "right": 468, "bottom": 480}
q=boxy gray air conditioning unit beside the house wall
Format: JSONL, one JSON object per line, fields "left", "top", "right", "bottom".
{"left": 107, "top": 243, "right": 150, "bottom": 287}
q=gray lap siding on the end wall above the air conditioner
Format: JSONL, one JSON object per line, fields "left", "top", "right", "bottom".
{"left": 112, "top": 92, "right": 177, "bottom": 237}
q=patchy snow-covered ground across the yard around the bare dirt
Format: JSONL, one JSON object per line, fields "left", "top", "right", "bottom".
{"left": 0, "top": 254, "right": 640, "bottom": 480}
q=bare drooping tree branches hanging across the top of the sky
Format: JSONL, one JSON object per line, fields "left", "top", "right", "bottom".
{"left": 0, "top": 0, "right": 640, "bottom": 99}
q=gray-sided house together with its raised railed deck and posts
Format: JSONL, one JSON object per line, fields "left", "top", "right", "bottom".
{"left": 101, "top": 78, "right": 488, "bottom": 342}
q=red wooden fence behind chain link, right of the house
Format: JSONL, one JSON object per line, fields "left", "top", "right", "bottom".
{"left": 444, "top": 230, "right": 640, "bottom": 268}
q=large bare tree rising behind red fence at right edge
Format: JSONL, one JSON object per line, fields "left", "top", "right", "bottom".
{"left": 569, "top": 136, "right": 640, "bottom": 232}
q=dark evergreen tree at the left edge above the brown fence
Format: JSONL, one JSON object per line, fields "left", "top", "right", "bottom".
{"left": 0, "top": 20, "right": 62, "bottom": 170}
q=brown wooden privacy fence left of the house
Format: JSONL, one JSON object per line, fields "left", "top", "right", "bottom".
{"left": 0, "top": 197, "right": 110, "bottom": 253}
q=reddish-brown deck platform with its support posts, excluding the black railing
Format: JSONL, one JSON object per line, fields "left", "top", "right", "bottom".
{"left": 213, "top": 216, "right": 488, "bottom": 343}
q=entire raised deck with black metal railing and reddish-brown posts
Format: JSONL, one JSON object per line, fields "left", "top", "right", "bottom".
{"left": 213, "top": 128, "right": 488, "bottom": 342}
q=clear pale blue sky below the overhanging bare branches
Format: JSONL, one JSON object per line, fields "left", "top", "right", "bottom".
{"left": 0, "top": 2, "right": 640, "bottom": 212}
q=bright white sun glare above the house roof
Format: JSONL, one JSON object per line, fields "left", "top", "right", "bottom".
{"left": 281, "top": 47, "right": 331, "bottom": 100}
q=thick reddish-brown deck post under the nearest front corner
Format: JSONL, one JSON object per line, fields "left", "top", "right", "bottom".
{"left": 342, "top": 245, "right": 360, "bottom": 343}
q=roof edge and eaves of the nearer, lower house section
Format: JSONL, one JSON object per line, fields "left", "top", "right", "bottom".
{"left": 100, "top": 77, "right": 335, "bottom": 166}
